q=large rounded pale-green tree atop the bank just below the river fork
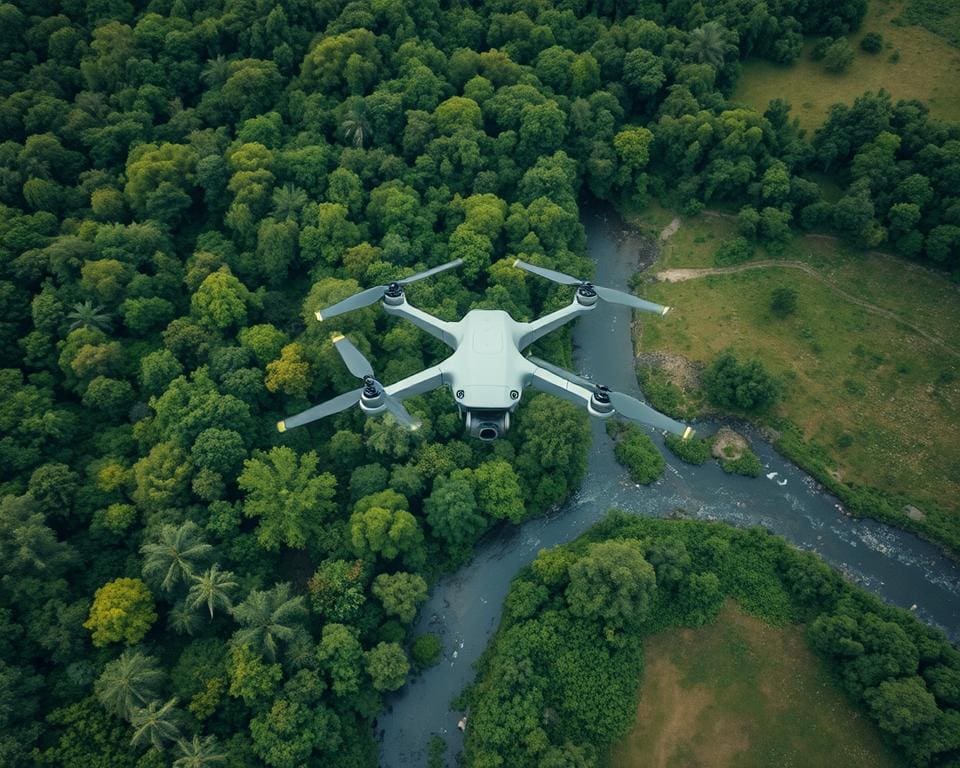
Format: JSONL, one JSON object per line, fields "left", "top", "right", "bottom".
{"left": 566, "top": 541, "right": 657, "bottom": 630}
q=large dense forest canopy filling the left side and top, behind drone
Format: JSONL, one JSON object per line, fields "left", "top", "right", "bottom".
{"left": 0, "top": 0, "right": 960, "bottom": 768}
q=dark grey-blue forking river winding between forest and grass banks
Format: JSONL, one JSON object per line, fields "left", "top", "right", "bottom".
{"left": 378, "top": 206, "right": 960, "bottom": 768}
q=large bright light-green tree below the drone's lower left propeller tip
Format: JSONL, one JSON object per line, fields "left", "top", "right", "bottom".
{"left": 237, "top": 446, "right": 337, "bottom": 551}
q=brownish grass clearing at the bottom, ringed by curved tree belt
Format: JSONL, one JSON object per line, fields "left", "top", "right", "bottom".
{"left": 611, "top": 603, "right": 898, "bottom": 768}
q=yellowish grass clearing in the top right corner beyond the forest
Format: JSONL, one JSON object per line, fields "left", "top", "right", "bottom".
{"left": 733, "top": 0, "right": 960, "bottom": 131}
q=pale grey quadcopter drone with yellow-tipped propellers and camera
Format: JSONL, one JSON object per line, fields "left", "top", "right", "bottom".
{"left": 277, "top": 259, "right": 693, "bottom": 442}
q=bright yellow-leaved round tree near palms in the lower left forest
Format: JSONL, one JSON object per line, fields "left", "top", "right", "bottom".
{"left": 83, "top": 578, "right": 157, "bottom": 647}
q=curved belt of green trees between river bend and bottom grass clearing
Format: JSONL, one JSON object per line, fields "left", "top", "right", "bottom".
{"left": 460, "top": 512, "right": 960, "bottom": 768}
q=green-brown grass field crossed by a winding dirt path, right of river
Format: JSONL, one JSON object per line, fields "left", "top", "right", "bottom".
{"left": 636, "top": 208, "right": 960, "bottom": 511}
